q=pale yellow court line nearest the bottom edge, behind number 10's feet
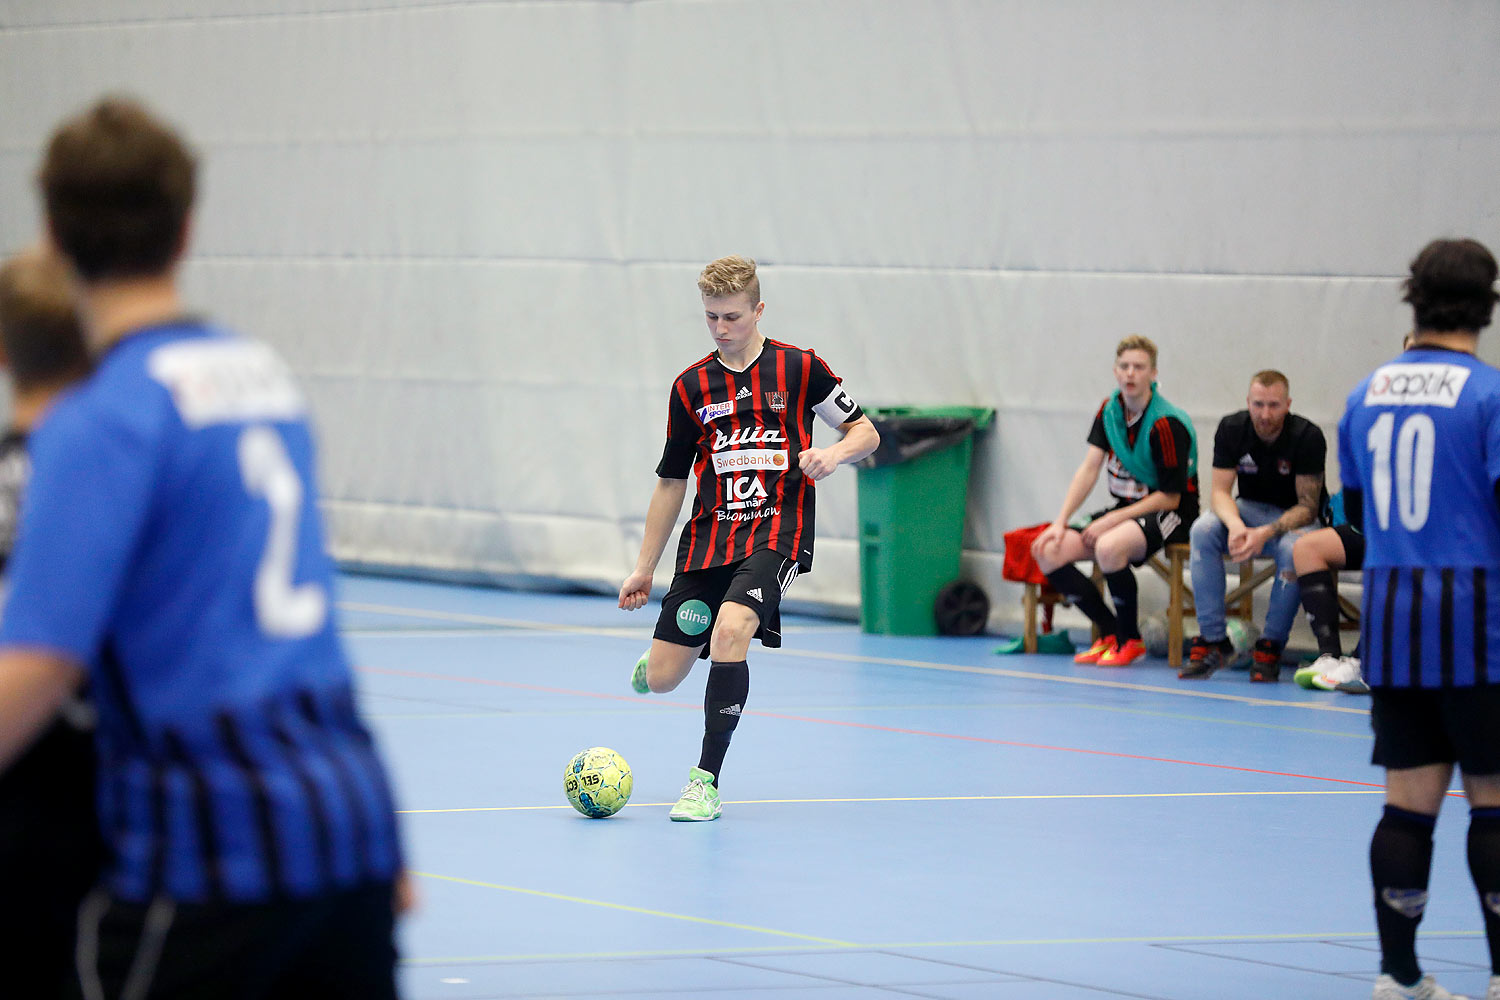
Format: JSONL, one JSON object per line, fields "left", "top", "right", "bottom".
{"left": 402, "top": 931, "right": 1484, "bottom": 966}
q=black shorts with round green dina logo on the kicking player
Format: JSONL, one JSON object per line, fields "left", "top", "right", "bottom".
{"left": 656, "top": 549, "right": 798, "bottom": 657}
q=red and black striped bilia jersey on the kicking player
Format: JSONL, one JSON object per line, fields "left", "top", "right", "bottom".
{"left": 657, "top": 339, "right": 863, "bottom": 573}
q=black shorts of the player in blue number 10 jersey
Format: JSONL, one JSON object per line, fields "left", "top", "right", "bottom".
{"left": 1370, "top": 685, "right": 1500, "bottom": 774}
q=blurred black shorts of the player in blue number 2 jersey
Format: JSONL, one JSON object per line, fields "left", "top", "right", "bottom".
{"left": 72, "top": 882, "right": 396, "bottom": 1000}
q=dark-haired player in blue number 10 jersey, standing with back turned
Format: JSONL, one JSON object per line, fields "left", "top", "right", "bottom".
{"left": 1338, "top": 240, "right": 1500, "bottom": 1000}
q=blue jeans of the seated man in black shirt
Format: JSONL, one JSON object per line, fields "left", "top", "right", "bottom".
{"left": 1190, "top": 499, "right": 1307, "bottom": 645}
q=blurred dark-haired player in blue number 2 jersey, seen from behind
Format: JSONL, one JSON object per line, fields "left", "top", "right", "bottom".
{"left": 0, "top": 99, "right": 401, "bottom": 1000}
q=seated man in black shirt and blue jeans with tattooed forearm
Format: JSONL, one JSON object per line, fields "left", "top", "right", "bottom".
{"left": 1178, "top": 369, "right": 1328, "bottom": 681}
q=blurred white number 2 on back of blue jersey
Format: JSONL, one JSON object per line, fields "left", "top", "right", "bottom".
{"left": 240, "top": 426, "right": 329, "bottom": 639}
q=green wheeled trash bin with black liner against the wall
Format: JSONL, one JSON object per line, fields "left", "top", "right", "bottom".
{"left": 858, "top": 406, "right": 995, "bottom": 636}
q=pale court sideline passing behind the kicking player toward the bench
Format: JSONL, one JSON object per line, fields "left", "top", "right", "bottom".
{"left": 339, "top": 603, "right": 1370, "bottom": 715}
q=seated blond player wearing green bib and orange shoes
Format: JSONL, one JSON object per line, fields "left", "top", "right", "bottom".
{"left": 1032, "top": 336, "right": 1199, "bottom": 667}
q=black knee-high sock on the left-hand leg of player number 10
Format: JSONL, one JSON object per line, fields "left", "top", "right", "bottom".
{"left": 1370, "top": 805, "right": 1437, "bottom": 985}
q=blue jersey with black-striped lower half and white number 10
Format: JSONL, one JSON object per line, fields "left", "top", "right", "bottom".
{"left": 1338, "top": 348, "right": 1500, "bottom": 688}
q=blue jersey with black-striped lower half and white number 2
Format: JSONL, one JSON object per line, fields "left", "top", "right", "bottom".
{"left": 0, "top": 321, "right": 401, "bottom": 903}
